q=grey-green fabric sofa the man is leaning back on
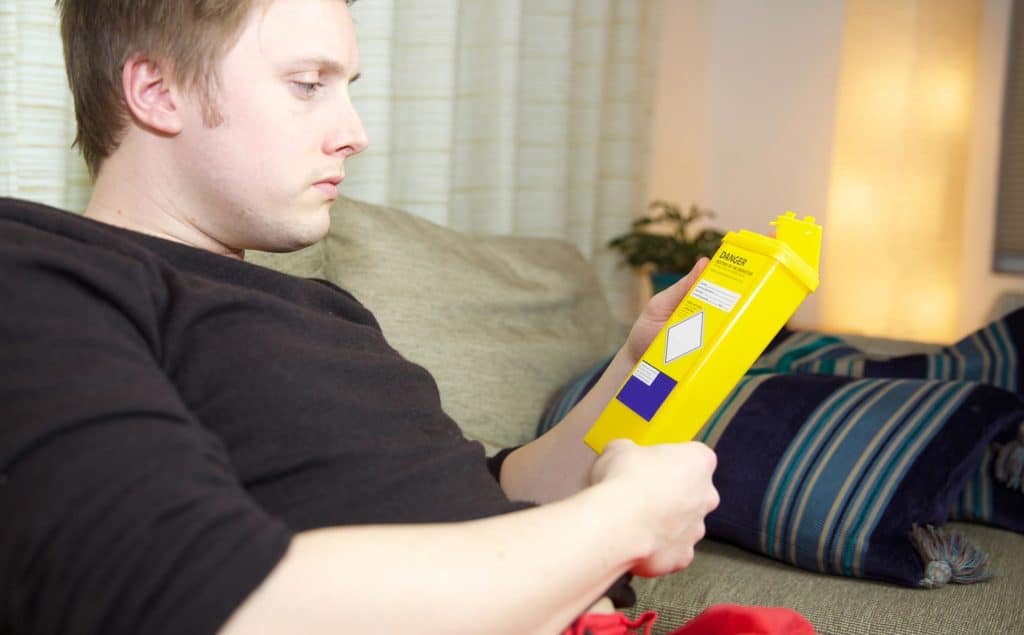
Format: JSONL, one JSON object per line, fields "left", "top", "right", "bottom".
{"left": 247, "top": 198, "right": 1024, "bottom": 634}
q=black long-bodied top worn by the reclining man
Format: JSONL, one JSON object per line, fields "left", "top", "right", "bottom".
{"left": 0, "top": 199, "right": 525, "bottom": 633}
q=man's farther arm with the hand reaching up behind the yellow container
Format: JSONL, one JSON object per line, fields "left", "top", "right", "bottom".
{"left": 501, "top": 258, "right": 708, "bottom": 503}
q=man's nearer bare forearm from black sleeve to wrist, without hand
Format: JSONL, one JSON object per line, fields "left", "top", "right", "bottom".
{"left": 222, "top": 483, "right": 644, "bottom": 634}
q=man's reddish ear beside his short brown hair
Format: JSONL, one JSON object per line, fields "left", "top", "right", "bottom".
{"left": 121, "top": 55, "right": 182, "bottom": 135}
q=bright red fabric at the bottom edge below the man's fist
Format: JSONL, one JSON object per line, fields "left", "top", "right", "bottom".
{"left": 562, "top": 604, "right": 814, "bottom": 635}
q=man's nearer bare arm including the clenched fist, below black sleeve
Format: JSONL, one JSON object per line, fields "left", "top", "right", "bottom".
{"left": 222, "top": 441, "right": 717, "bottom": 635}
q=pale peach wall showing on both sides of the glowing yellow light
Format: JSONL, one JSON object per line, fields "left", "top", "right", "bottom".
{"left": 650, "top": 0, "right": 1024, "bottom": 340}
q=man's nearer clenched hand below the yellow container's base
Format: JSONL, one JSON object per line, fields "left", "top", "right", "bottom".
{"left": 591, "top": 439, "right": 719, "bottom": 578}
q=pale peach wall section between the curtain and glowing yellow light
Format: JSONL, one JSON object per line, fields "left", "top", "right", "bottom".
{"left": 650, "top": 0, "right": 844, "bottom": 327}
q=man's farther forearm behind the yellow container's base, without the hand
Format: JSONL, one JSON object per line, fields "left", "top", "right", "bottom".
{"left": 501, "top": 348, "right": 633, "bottom": 503}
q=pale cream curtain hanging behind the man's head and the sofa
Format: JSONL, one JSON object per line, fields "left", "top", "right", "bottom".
{"left": 0, "top": 0, "right": 658, "bottom": 316}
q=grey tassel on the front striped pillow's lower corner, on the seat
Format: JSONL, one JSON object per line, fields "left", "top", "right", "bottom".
{"left": 910, "top": 524, "right": 991, "bottom": 589}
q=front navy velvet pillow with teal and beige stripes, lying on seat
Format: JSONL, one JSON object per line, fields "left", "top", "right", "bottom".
{"left": 698, "top": 375, "right": 1024, "bottom": 586}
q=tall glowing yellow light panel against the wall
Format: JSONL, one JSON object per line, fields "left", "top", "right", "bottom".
{"left": 820, "top": 0, "right": 981, "bottom": 342}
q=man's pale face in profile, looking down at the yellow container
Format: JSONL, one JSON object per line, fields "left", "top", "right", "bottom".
{"left": 173, "top": 0, "right": 367, "bottom": 251}
